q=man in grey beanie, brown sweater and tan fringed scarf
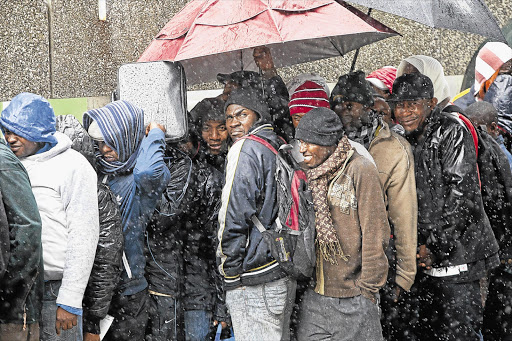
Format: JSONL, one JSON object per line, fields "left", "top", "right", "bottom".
{"left": 295, "top": 108, "right": 390, "bottom": 341}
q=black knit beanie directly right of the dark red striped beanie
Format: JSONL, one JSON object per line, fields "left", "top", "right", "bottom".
{"left": 329, "top": 71, "right": 373, "bottom": 108}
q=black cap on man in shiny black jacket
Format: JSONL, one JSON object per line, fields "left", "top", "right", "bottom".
{"left": 388, "top": 73, "right": 434, "bottom": 102}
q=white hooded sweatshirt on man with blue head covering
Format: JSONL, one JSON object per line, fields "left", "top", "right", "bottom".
{"left": 21, "top": 132, "right": 99, "bottom": 308}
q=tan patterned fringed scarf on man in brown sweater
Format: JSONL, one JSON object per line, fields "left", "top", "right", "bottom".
{"left": 306, "top": 136, "right": 352, "bottom": 264}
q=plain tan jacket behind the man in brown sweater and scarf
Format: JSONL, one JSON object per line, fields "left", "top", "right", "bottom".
{"left": 369, "top": 123, "right": 418, "bottom": 290}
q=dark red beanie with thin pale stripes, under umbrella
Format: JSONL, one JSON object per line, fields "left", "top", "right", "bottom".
{"left": 288, "top": 80, "right": 330, "bottom": 116}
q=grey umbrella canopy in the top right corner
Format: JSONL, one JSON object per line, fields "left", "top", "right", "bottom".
{"left": 340, "top": 0, "right": 505, "bottom": 42}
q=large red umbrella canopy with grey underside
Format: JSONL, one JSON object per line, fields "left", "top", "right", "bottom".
{"left": 138, "top": 0, "right": 398, "bottom": 84}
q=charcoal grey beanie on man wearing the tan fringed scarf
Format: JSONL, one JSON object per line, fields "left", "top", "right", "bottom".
{"left": 295, "top": 107, "right": 343, "bottom": 146}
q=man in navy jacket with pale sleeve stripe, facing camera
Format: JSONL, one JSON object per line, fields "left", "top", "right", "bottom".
{"left": 217, "top": 89, "right": 296, "bottom": 340}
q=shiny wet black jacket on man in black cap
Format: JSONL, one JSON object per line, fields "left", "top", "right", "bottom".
{"left": 408, "top": 108, "right": 498, "bottom": 267}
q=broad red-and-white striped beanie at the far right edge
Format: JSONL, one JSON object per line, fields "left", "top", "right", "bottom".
{"left": 473, "top": 42, "right": 512, "bottom": 99}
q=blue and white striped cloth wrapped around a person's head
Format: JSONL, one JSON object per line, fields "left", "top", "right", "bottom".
{"left": 83, "top": 101, "right": 144, "bottom": 174}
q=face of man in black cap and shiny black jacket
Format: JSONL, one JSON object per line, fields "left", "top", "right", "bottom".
{"left": 395, "top": 98, "right": 437, "bottom": 134}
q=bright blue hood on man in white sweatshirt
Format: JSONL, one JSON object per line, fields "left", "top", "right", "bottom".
{"left": 0, "top": 92, "right": 57, "bottom": 144}
